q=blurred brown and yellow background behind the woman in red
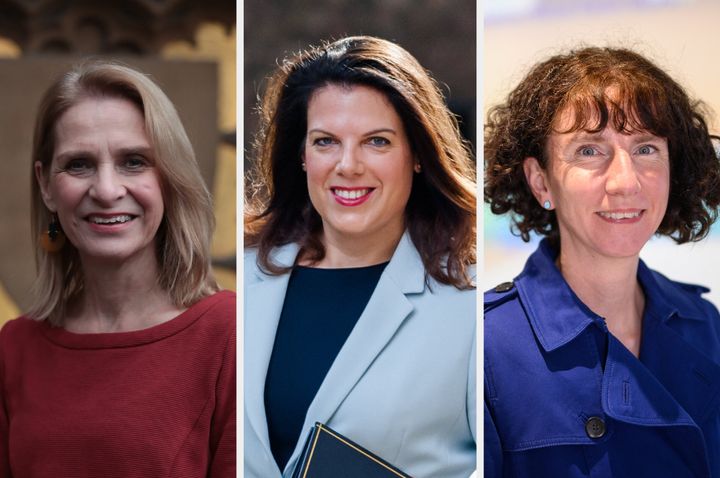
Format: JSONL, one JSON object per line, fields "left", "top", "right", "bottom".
{"left": 0, "top": 0, "right": 236, "bottom": 325}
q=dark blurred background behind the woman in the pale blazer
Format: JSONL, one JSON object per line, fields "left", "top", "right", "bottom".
{"left": 243, "top": 0, "right": 477, "bottom": 174}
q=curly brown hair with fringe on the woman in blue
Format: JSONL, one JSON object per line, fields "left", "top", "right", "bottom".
{"left": 484, "top": 47, "right": 720, "bottom": 244}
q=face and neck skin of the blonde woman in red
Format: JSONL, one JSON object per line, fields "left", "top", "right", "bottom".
{"left": 35, "top": 97, "right": 182, "bottom": 333}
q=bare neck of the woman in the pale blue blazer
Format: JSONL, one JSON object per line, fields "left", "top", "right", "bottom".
{"left": 312, "top": 224, "right": 405, "bottom": 269}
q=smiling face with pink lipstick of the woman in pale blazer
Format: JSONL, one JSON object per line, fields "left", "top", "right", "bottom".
{"left": 303, "top": 85, "right": 413, "bottom": 248}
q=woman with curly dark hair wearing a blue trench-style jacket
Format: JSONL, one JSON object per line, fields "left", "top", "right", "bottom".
{"left": 484, "top": 48, "right": 720, "bottom": 477}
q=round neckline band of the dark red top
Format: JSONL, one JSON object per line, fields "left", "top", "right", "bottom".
{"left": 40, "top": 291, "right": 232, "bottom": 349}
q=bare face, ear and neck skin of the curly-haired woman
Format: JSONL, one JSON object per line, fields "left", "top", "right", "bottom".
{"left": 524, "top": 106, "right": 670, "bottom": 356}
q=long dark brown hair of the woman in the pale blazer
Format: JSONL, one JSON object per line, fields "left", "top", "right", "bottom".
{"left": 245, "top": 36, "right": 476, "bottom": 288}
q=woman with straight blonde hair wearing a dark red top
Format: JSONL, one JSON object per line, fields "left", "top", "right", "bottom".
{"left": 0, "top": 61, "right": 236, "bottom": 478}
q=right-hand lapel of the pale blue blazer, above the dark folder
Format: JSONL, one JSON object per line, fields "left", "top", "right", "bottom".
{"left": 286, "top": 233, "right": 425, "bottom": 470}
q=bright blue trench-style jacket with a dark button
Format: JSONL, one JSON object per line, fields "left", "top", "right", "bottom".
{"left": 484, "top": 241, "right": 720, "bottom": 478}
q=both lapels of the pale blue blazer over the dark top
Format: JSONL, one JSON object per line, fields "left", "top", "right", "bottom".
{"left": 245, "top": 232, "right": 426, "bottom": 470}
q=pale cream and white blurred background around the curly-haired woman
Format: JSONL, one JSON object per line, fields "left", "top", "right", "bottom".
{"left": 480, "top": 0, "right": 720, "bottom": 306}
